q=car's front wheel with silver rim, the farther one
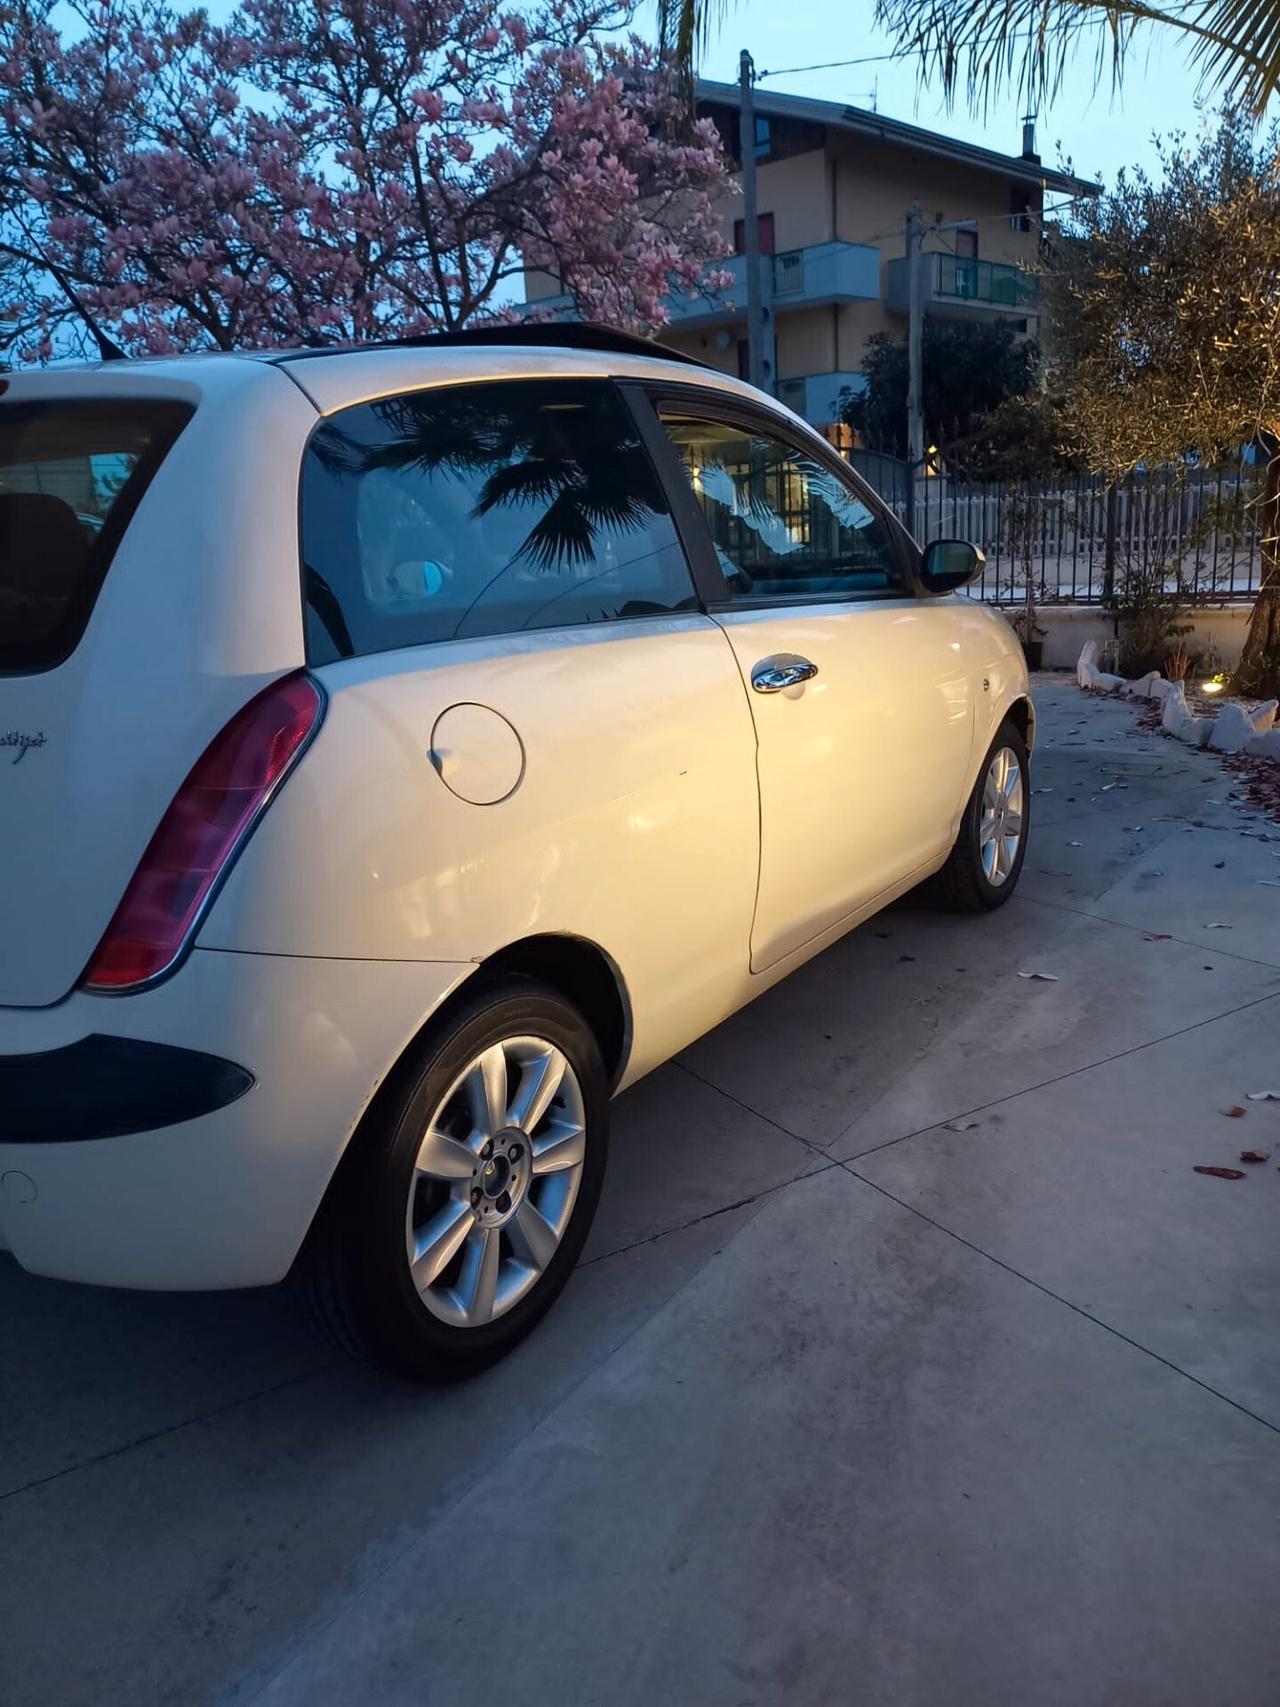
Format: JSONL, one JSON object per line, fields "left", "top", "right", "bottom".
{"left": 934, "top": 722, "right": 1031, "bottom": 913}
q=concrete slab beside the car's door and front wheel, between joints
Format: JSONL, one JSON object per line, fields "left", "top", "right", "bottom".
{"left": 681, "top": 891, "right": 1280, "bottom": 1157}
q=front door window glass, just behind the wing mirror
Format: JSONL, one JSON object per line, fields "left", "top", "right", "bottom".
{"left": 659, "top": 403, "right": 906, "bottom": 604}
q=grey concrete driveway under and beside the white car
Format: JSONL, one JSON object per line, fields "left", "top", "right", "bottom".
{"left": 0, "top": 683, "right": 1280, "bottom": 1707}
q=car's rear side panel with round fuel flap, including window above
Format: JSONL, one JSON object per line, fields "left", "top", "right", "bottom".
{"left": 221, "top": 374, "right": 759, "bottom": 1074}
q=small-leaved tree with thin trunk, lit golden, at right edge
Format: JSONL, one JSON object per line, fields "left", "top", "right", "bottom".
{"left": 1050, "top": 123, "right": 1280, "bottom": 695}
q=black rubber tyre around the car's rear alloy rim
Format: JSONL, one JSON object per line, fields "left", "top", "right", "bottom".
{"left": 308, "top": 976, "right": 609, "bottom": 1381}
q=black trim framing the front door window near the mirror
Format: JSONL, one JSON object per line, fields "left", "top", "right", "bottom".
{"left": 618, "top": 381, "right": 922, "bottom": 615}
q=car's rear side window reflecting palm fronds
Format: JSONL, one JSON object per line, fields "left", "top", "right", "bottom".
{"left": 302, "top": 379, "right": 696, "bottom": 662}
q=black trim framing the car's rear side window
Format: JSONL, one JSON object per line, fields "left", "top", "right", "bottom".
{"left": 297, "top": 375, "right": 706, "bottom": 669}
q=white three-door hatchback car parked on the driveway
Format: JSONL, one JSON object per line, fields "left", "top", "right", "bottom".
{"left": 0, "top": 328, "right": 1034, "bottom": 1378}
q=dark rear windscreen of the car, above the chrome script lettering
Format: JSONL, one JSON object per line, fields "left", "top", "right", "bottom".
{"left": 0, "top": 398, "right": 193, "bottom": 676}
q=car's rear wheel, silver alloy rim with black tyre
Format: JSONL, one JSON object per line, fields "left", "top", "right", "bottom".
{"left": 307, "top": 978, "right": 609, "bottom": 1381}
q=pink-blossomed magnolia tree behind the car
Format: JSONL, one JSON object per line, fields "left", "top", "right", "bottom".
{"left": 0, "top": 0, "right": 730, "bottom": 357}
